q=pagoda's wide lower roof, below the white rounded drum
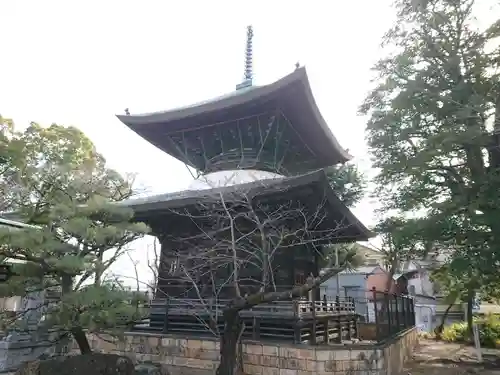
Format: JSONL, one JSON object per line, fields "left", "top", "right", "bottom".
{"left": 120, "top": 170, "right": 373, "bottom": 242}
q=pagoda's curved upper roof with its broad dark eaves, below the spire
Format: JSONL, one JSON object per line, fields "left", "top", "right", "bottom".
{"left": 117, "top": 67, "right": 351, "bottom": 173}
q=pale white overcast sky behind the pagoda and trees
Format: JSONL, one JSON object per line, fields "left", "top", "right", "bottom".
{"left": 0, "top": 0, "right": 394, "bottom": 288}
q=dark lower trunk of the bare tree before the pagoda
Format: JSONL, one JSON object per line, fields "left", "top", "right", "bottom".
{"left": 216, "top": 310, "right": 243, "bottom": 375}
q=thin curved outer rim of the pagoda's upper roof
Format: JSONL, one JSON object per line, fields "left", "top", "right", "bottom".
{"left": 117, "top": 67, "right": 352, "bottom": 163}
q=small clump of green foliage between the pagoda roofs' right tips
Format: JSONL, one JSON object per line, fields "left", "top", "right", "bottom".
{"left": 325, "top": 163, "right": 366, "bottom": 207}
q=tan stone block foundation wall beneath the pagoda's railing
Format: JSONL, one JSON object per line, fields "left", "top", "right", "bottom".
{"left": 77, "top": 330, "right": 418, "bottom": 375}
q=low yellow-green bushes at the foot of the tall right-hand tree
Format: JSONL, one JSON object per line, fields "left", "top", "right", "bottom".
{"left": 441, "top": 315, "right": 500, "bottom": 348}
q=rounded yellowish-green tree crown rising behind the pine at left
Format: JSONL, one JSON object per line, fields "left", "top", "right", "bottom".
{"left": 0, "top": 122, "right": 132, "bottom": 224}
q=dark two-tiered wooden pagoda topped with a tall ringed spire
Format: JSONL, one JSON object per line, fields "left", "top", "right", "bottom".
{"left": 117, "top": 28, "right": 371, "bottom": 341}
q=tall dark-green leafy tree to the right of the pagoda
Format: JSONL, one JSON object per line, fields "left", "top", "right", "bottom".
{"left": 361, "top": 0, "right": 500, "bottom": 334}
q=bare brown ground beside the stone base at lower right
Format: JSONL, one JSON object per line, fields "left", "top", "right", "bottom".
{"left": 405, "top": 340, "right": 500, "bottom": 375}
